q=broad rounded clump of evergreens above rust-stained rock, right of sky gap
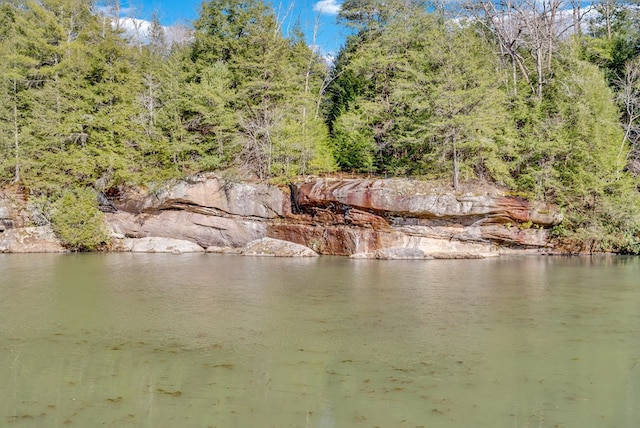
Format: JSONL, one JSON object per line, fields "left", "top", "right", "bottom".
{"left": 327, "top": 9, "right": 510, "bottom": 182}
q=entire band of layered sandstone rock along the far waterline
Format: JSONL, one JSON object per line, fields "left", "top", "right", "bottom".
{"left": 0, "top": 175, "right": 562, "bottom": 259}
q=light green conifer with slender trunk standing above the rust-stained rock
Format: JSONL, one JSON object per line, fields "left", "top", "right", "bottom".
{"left": 416, "top": 19, "right": 510, "bottom": 190}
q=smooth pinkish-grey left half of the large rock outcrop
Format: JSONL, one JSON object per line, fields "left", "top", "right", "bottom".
{"left": 106, "top": 176, "right": 282, "bottom": 248}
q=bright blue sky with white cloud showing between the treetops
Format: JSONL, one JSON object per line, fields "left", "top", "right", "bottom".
{"left": 110, "top": 0, "right": 346, "bottom": 55}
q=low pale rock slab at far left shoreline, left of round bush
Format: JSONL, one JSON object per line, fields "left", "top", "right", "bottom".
{"left": 0, "top": 226, "right": 66, "bottom": 253}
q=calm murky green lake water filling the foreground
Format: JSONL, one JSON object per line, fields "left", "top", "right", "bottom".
{"left": 0, "top": 254, "right": 640, "bottom": 428}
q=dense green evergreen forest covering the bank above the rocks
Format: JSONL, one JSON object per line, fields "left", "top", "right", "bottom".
{"left": 0, "top": 0, "right": 640, "bottom": 254}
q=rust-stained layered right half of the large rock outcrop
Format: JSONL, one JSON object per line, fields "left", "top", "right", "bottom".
{"left": 268, "top": 179, "right": 562, "bottom": 258}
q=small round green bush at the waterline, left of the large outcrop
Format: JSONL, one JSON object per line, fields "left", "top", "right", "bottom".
{"left": 51, "top": 188, "right": 109, "bottom": 251}
